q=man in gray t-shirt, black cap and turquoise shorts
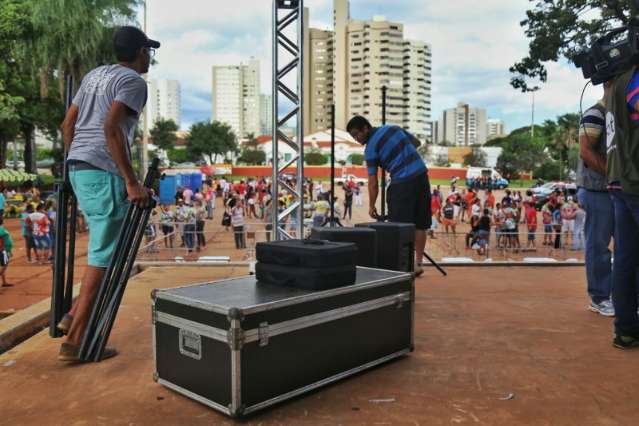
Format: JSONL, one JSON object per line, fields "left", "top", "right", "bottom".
{"left": 58, "top": 27, "right": 160, "bottom": 362}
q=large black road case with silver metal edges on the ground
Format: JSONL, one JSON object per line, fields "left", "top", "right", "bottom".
{"left": 152, "top": 267, "right": 415, "bottom": 417}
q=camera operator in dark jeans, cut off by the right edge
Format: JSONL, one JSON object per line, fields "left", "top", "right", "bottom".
{"left": 605, "top": 67, "right": 639, "bottom": 349}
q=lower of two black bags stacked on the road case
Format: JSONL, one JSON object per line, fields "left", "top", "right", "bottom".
{"left": 255, "top": 263, "right": 356, "bottom": 291}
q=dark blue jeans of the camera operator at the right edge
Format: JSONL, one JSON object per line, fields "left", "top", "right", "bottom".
{"left": 611, "top": 191, "right": 639, "bottom": 335}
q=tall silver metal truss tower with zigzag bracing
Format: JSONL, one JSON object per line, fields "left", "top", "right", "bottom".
{"left": 271, "top": 0, "right": 304, "bottom": 240}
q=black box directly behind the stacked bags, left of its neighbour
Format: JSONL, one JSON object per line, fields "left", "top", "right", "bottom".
{"left": 311, "top": 227, "right": 377, "bottom": 268}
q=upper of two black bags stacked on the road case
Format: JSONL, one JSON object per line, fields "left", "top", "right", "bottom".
{"left": 255, "top": 240, "right": 357, "bottom": 268}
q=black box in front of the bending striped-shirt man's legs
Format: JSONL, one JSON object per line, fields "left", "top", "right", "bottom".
{"left": 355, "top": 222, "right": 415, "bottom": 272}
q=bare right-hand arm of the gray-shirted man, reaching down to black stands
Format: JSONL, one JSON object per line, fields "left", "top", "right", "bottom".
{"left": 104, "top": 101, "right": 149, "bottom": 207}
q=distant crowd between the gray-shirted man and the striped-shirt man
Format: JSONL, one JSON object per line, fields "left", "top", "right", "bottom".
{"left": 145, "top": 178, "right": 363, "bottom": 253}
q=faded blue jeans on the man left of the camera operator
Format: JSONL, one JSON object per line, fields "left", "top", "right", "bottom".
{"left": 577, "top": 188, "right": 615, "bottom": 303}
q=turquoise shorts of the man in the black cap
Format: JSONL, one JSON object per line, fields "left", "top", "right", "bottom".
{"left": 69, "top": 170, "right": 129, "bottom": 268}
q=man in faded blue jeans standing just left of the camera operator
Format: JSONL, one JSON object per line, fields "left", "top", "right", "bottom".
{"left": 577, "top": 90, "right": 615, "bottom": 316}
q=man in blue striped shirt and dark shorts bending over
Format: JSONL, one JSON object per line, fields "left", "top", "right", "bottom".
{"left": 346, "top": 116, "right": 432, "bottom": 276}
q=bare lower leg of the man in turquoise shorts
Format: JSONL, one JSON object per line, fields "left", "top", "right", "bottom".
{"left": 67, "top": 266, "right": 106, "bottom": 346}
